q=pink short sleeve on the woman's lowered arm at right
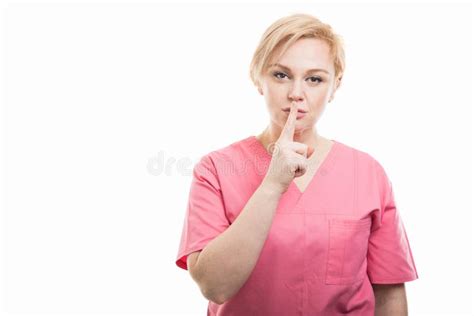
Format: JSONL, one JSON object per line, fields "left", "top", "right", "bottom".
{"left": 367, "top": 161, "right": 418, "bottom": 284}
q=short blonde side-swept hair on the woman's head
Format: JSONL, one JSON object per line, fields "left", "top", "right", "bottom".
{"left": 250, "top": 13, "right": 345, "bottom": 87}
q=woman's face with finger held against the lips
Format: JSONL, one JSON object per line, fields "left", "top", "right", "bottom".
{"left": 258, "top": 38, "right": 340, "bottom": 133}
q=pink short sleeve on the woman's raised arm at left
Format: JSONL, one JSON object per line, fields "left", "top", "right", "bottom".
{"left": 176, "top": 154, "right": 230, "bottom": 270}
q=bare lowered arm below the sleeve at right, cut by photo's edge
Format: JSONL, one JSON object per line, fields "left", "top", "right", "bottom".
{"left": 372, "top": 283, "right": 408, "bottom": 316}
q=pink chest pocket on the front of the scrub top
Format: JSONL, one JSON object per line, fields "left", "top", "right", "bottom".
{"left": 325, "top": 218, "right": 372, "bottom": 284}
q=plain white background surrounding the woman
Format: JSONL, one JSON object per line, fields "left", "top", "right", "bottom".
{"left": 0, "top": 1, "right": 474, "bottom": 315}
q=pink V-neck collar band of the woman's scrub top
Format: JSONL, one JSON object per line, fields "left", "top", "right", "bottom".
{"left": 249, "top": 135, "right": 340, "bottom": 199}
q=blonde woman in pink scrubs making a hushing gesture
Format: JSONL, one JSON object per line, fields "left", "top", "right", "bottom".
{"left": 176, "top": 14, "right": 418, "bottom": 316}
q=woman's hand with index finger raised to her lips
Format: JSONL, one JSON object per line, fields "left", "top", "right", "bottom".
{"left": 264, "top": 102, "right": 314, "bottom": 192}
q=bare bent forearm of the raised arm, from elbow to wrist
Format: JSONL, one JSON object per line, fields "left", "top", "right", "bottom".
{"left": 196, "top": 181, "right": 283, "bottom": 303}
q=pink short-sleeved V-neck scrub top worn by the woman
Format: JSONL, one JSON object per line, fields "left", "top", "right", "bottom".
{"left": 176, "top": 136, "right": 418, "bottom": 316}
